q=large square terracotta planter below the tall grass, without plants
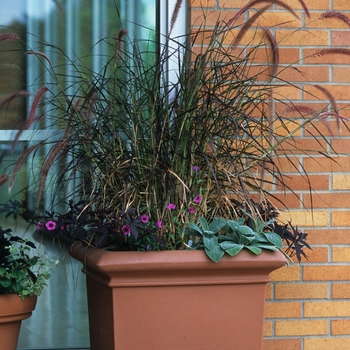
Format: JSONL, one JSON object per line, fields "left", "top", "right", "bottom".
{"left": 71, "top": 244, "right": 285, "bottom": 350}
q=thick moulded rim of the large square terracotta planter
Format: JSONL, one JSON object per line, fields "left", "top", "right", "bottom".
{"left": 70, "top": 242, "right": 286, "bottom": 287}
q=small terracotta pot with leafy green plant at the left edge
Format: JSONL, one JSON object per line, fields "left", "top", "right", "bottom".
{"left": 0, "top": 227, "right": 58, "bottom": 350}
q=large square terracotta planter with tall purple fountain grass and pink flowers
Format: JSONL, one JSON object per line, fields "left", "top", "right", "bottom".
{"left": 2, "top": 0, "right": 340, "bottom": 350}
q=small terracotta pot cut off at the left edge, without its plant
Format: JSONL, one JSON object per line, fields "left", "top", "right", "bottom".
{"left": 0, "top": 294, "right": 37, "bottom": 350}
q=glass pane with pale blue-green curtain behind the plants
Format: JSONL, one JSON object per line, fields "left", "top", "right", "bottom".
{"left": 0, "top": 0, "right": 157, "bottom": 350}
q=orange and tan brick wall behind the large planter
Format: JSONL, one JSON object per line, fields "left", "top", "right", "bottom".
{"left": 191, "top": 0, "right": 350, "bottom": 350}
